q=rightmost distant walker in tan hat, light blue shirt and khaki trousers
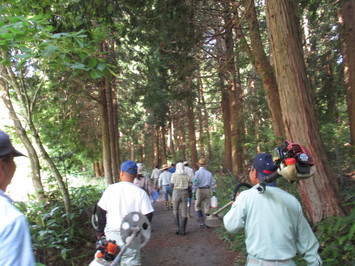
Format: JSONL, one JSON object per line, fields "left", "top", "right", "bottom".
{"left": 192, "top": 158, "right": 216, "bottom": 229}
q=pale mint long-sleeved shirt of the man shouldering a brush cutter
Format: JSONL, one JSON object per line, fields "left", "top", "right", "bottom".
{"left": 223, "top": 187, "right": 318, "bottom": 260}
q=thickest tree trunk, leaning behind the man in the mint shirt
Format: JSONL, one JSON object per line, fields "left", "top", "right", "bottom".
{"left": 266, "top": 0, "right": 344, "bottom": 223}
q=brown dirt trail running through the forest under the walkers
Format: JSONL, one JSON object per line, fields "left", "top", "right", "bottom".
{"left": 141, "top": 194, "right": 244, "bottom": 266}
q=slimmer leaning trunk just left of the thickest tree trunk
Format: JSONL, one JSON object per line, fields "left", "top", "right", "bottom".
{"left": 236, "top": 0, "right": 285, "bottom": 140}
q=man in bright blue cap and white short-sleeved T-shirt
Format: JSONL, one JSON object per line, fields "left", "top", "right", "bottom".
{"left": 96, "top": 161, "right": 154, "bottom": 265}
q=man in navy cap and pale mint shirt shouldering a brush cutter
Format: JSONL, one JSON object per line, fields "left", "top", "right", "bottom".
{"left": 223, "top": 153, "right": 322, "bottom": 266}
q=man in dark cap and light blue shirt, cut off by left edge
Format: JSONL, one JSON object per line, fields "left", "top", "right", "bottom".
{"left": 0, "top": 131, "right": 35, "bottom": 266}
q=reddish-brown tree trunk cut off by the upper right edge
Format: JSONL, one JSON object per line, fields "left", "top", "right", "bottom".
{"left": 339, "top": 0, "right": 355, "bottom": 146}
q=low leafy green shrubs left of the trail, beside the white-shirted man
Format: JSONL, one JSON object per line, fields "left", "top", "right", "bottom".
{"left": 17, "top": 181, "right": 102, "bottom": 265}
